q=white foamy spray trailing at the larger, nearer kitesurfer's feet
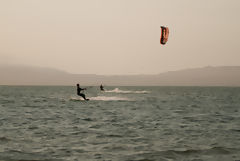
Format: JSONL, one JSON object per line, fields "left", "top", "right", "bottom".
{"left": 70, "top": 96, "right": 133, "bottom": 101}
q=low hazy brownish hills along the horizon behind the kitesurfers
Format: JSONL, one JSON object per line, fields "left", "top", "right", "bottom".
{"left": 0, "top": 65, "right": 240, "bottom": 86}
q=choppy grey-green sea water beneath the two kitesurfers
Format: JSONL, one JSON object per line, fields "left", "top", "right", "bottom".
{"left": 0, "top": 86, "right": 240, "bottom": 161}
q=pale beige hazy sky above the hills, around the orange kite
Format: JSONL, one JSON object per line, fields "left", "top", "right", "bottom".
{"left": 0, "top": 0, "right": 240, "bottom": 74}
